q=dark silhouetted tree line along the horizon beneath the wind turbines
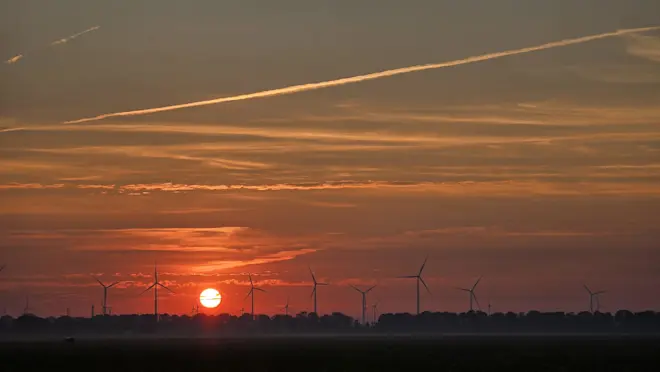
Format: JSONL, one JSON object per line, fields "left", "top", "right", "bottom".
{"left": 0, "top": 310, "right": 660, "bottom": 336}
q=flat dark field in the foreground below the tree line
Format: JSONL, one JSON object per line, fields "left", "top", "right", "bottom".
{"left": 0, "top": 336, "right": 660, "bottom": 372}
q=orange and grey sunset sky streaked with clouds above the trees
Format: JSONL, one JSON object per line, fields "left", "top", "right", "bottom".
{"left": 0, "top": 0, "right": 660, "bottom": 317}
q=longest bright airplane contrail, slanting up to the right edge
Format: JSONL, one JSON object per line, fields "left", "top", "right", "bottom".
{"left": 64, "top": 26, "right": 660, "bottom": 124}
